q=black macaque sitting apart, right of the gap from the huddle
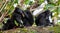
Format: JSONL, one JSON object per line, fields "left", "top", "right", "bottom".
{"left": 35, "top": 10, "right": 52, "bottom": 26}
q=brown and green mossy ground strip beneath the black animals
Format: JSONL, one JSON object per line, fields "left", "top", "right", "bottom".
{"left": 0, "top": 26, "right": 60, "bottom": 33}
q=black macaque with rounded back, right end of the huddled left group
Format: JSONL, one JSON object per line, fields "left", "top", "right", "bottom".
{"left": 23, "top": 10, "right": 34, "bottom": 26}
